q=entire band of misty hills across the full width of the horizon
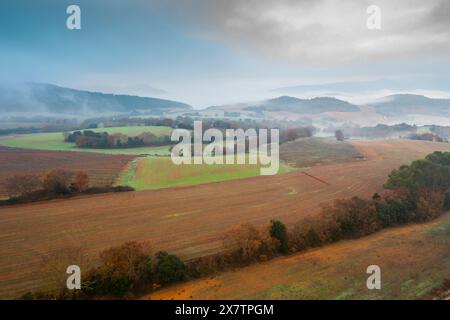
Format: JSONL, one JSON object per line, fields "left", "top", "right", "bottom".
{"left": 0, "top": 83, "right": 450, "bottom": 126}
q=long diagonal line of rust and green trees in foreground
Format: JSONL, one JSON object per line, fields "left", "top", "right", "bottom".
{"left": 22, "top": 152, "right": 450, "bottom": 299}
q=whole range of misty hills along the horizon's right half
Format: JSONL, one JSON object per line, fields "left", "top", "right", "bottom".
{"left": 202, "top": 94, "right": 450, "bottom": 125}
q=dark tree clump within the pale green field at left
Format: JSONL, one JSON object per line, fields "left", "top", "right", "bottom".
{"left": 64, "top": 130, "right": 172, "bottom": 149}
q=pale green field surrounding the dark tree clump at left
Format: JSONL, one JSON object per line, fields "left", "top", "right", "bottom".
{"left": 0, "top": 126, "right": 172, "bottom": 155}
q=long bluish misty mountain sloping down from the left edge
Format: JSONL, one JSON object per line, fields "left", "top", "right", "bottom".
{"left": 0, "top": 83, "right": 192, "bottom": 115}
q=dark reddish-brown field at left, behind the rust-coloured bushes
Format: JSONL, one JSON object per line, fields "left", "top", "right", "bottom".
{"left": 0, "top": 146, "right": 135, "bottom": 198}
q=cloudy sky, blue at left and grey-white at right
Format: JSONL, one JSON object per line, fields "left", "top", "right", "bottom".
{"left": 0, "top": 0, "right": 450, "bottom": 108}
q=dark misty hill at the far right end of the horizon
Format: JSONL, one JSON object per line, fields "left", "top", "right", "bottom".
{"left": 371, "top": 94, "right": 450, "bottom": 117}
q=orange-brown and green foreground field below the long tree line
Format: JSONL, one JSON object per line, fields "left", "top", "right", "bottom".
{"left": 144, "top": 213, "right": 450, "bottom": 299}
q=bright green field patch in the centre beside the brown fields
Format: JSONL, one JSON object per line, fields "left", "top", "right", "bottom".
{"left": 118, "top": 157, "right": 293, "bottom": 190}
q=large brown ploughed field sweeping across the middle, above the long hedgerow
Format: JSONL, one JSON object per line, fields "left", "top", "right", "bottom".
{"left": 0, "top": 140, "right": 450, "bottom": 298}
